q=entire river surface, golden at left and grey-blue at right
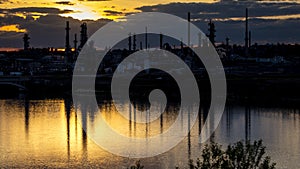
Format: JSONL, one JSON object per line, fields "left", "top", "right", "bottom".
{"left": 0, "top": 99, "right": 300, "bottom": 168}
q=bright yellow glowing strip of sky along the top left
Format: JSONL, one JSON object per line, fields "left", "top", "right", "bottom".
{"left": 0, "top": 0, "right": 219, "bottom": 20}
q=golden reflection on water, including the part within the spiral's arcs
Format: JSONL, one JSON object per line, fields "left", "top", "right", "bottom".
{"left": 0, "top": 99, "right": 185, "bottom": 168}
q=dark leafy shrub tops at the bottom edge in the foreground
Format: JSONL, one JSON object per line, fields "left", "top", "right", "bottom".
{"left": 130, "top": 140, "right": 276, "bottom": 169}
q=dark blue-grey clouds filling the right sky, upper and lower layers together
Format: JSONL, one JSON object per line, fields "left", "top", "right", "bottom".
{"left": 137, "top": 0, "right": 300, "bottom": 43}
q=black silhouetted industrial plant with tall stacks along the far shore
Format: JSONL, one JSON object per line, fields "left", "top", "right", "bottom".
{"left": 0, "top": 9, "right": 300, "bottom": 103}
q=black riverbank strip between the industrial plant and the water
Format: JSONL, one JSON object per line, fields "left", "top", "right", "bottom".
{"left": 0, "top": 75, "right": 300, "bottom": 106}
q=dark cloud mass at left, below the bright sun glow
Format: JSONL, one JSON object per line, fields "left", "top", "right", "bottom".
{"left": 0, "top": 8, "right": 110, "bottom": 47}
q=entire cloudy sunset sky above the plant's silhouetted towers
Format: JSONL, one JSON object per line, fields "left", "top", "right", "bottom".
{"left": 0, "top": 0, "right": 300, "bottom": 48}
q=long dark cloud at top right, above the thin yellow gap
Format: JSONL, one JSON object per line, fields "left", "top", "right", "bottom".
{"left": 136, "top": 1, "right": 300, "bottom": 18}
